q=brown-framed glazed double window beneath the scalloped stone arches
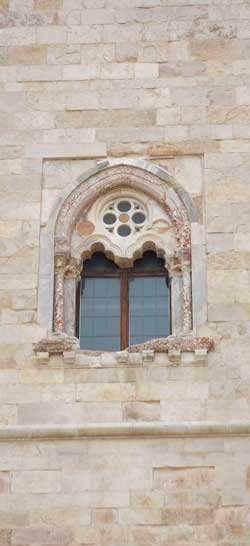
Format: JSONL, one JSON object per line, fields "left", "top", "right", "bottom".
{"left": 76, "top": 250, "right": 170, "bottom": 351}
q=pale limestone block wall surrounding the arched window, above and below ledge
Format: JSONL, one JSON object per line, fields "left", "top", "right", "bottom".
{"left": 0, "top": 0, "right": 250, "bottom": 546}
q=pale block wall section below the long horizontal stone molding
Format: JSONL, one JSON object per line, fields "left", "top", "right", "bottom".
{"left": 0, "top": 430, "right": 250, "bottom": 546}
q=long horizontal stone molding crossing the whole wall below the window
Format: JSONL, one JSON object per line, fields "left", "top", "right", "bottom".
{"left": 0, "top": 421, "right": 250, "bottom": 442}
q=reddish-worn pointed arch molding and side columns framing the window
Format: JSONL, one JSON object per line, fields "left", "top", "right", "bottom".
{"left": 37, "top": 159, "right": 205, "bottom": 344}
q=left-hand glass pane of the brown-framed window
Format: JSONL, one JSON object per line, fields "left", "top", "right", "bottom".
{"left": 80, "top": 278, "right": 120, "bottom": 351}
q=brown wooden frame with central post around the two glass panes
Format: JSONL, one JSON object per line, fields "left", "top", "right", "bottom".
{"left": 75, "top": 267, "right": 172, "bottom": 351}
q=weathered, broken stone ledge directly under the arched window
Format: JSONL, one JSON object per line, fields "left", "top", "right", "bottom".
{"left": 34, "top": 333, "right": 214, "bottom": 367}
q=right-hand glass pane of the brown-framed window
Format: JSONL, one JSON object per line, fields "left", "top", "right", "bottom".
{"left": 129, "top": 277, "right": 170, "bottom": 345}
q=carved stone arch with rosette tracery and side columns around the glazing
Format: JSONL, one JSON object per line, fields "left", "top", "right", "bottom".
{"left": 32, "top": 160, "right": 211, "bottom": 351}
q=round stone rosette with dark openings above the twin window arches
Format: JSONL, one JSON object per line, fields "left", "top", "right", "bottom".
{"left": 102, "top": 198, "right": 148, "bottom": 237}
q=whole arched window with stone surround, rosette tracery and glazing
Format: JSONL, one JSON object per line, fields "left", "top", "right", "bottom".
{"left": 38, "top": 159, "right": 210, "bottom": 351}
